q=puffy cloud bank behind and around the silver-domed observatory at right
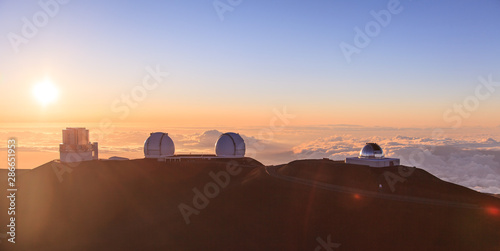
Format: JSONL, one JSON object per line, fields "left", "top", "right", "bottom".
{"left": 293, "top": 135, "right": 500, "bottom": 193}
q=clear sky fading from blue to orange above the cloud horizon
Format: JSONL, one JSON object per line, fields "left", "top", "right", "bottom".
{"left": 0, "top": 0, "right": 500, "bottom": 127}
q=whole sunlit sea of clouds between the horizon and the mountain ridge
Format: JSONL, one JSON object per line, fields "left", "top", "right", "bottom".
{"left": 0, "top": 125, "right": 500, "bottom": 194}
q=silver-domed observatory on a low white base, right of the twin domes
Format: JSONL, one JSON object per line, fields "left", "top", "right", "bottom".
{"left": 345, "top": 143, "right": 400, "bottom": 167}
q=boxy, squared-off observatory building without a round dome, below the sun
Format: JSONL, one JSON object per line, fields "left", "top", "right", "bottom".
{"left": 59, "top": 127, "right": 99, "bottom": 162}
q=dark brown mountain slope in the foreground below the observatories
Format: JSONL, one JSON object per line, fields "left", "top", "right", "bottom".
{"left": 0, "top": 158, "right": 500, "bottom": 250}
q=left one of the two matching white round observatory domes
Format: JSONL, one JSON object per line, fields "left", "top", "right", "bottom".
{"left": 144, "top": 132, "right": 175, "bottom": 158}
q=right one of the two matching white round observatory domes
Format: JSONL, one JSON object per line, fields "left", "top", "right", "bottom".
{"left": 215, "top": 132, "right": 245, "bottom": 157}
